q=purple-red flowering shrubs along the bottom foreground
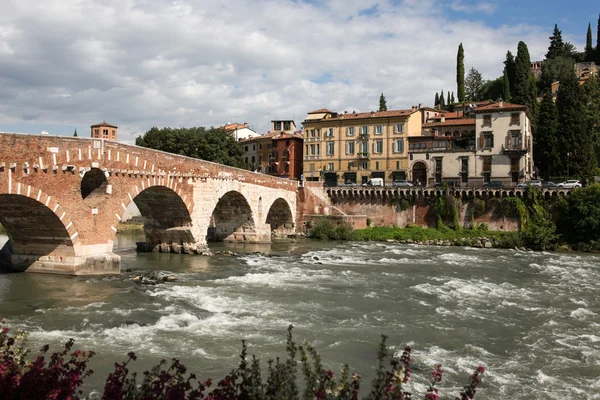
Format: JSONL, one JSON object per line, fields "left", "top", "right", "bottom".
{"left": 0, "top": 325, "right": 484, "bottom": 400}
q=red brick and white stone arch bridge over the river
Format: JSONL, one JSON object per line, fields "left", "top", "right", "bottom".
{"left": 0, "top": 133, "right": 298, "bottom": 275}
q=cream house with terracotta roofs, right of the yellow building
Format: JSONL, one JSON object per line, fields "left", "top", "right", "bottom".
{"left": 407, "top": 101, "right": 533, "bottom": 187}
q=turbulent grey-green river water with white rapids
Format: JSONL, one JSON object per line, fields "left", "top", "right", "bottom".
{"left": 0, "top": 236, "right": 600, "bottom": 399}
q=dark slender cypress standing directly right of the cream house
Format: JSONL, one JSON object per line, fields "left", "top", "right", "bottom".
{"left": 533, "top": 89, "right": 562, "bottom": 180}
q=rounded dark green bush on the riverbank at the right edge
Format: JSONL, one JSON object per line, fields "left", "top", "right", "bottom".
{"left": 557, "top": 184, "right": 600, "bottom": 243}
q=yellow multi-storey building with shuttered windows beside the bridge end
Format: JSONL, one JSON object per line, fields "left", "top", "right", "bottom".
{"left": 302, "top": 107, "right": 422, "bottom": 186}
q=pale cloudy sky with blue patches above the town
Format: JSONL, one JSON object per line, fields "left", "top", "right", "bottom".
{"left": 0, "top": 0, "right": 600, "bottom": 142}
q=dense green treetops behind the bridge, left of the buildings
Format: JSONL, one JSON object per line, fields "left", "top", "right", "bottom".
{"left": 135, "top": 127, "right": 248, "bottom": 168}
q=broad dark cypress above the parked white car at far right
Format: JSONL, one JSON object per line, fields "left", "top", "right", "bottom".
{"left": 556, "top": 71, "right": 596, "bottom": 178}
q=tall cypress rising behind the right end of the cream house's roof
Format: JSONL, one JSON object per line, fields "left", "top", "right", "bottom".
{"left": 510, "top": 41, "right": 537, "bottom": 120}
